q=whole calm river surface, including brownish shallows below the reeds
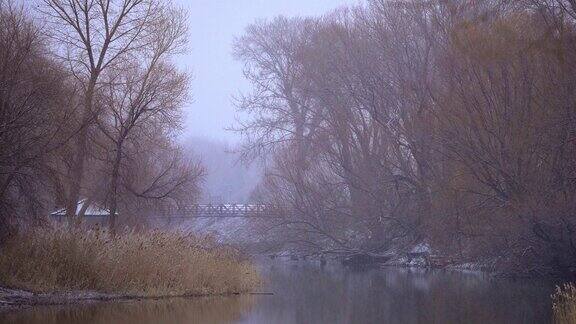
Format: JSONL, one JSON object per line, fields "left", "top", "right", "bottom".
{"left": 0, "top": 261, "right": 552, "bottom": 324}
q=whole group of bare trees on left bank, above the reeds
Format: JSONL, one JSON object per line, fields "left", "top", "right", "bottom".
{"left": 0, "top": 0, "right": 203, "bottom": 234}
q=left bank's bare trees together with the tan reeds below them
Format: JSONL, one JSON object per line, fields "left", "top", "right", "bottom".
{"left": 0, "top": 0, "right": 264, "bottom": 296}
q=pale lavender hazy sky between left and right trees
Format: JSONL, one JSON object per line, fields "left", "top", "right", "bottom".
{"left": 176, "top": 0, "right": 358, "bottom": 142}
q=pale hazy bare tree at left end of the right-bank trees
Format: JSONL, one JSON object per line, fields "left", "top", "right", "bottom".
{"left": 234, "top": 17, "right": 317, "bottom": 169}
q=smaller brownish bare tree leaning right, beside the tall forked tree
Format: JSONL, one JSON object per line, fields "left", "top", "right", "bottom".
{"left": 98, "top": 6, "right": 188, "bottom": 227}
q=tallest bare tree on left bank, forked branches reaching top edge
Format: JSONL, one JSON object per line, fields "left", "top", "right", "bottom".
{"left": 41, "top": 0, "right": 171, "bottom": 217}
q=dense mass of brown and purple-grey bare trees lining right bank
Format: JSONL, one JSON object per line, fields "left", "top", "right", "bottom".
{"left": 235, "top": 0, "right": 576, "bottom": 276}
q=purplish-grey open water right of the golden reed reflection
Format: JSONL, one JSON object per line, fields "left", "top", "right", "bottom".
{"left": 246, "top": 264, "right": 552, "bottom": 324}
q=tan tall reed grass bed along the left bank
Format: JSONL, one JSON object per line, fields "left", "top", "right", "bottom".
{"left": 0, "top": 227, "right": 259, "bottom": 296}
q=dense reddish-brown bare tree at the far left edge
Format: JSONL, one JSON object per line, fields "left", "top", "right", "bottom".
{"left": 0, "top": 1, "right": 75, "bottom": 238}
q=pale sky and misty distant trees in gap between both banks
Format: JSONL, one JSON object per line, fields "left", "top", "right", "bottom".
{"left": 177, "top": 0, "right": 358, "bottom": 202}
